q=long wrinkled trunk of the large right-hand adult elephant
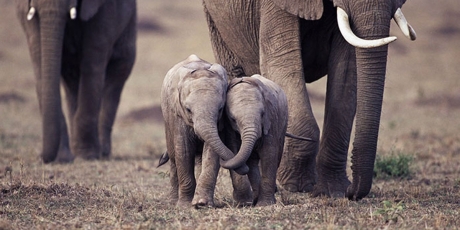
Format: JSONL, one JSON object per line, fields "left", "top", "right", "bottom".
{"left": 347, "top": 4, "right": 391, "bottom": 200}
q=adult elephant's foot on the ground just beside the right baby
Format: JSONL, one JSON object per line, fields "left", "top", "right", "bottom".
{"left": 277, "top": 156, "right": 316, "bottom": 192}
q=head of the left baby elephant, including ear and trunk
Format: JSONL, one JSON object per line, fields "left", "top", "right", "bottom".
{"left": 162, "top": 55, "right": 249, "bottom": 174}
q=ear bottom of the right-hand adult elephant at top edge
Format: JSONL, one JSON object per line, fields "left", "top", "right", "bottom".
{"left": 273, "top": 0, "right": 324, "bottom": 20}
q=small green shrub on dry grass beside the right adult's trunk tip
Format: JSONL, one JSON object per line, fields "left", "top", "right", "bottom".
{"left": 374, "top": 153, "right": 413, "bottom": 179}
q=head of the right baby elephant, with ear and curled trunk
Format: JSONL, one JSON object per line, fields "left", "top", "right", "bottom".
{"left": 221, "top": 75, "right": 287, "bottom": 169}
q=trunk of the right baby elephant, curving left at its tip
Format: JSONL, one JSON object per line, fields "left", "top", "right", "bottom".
{"left": 221, "top": 128, "right": 259, "bottom": 169}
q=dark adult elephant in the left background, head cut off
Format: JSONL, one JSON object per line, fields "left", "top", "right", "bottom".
{"left": 16, "top": 0, "right": 136, "bottom": 163}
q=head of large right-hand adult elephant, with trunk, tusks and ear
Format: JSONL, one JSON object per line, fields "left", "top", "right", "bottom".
{"left": 273, "top": 0, "right": 416, "bottom": 200}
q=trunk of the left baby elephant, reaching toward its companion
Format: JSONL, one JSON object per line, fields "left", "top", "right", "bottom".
{"left": 195, "top": 121, "right": 249, "bottom": 175}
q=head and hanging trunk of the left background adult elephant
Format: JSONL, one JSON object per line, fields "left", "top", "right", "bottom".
{"left": 16, "top": 0, "right": 109, "bottom": 163}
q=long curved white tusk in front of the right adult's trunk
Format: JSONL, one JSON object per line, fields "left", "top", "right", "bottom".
{"left": 337, "top": 7, "right": 397, "bottom": 48}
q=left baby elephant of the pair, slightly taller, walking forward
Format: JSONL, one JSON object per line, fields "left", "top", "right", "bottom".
{"left": 161, "top": 55, "right": 248, "bottom": 206}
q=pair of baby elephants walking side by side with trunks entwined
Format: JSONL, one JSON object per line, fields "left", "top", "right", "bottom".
{"left": 160, "top": 55, "right": 310, "bottom": 206}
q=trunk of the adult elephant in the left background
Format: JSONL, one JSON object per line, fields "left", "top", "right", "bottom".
{"left": 37, "top": 4, "right": 66, "bottom": 163}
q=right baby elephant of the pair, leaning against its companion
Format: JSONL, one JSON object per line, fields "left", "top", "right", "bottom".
{"left": 221, "top": 75, "right": 288, "bottom": 206}
